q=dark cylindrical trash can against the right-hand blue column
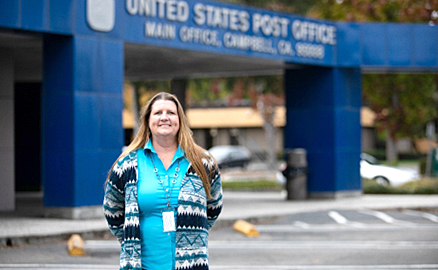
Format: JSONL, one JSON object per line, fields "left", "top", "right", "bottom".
{"left": 285, "top": 148, "right": 307, "bottom": 200}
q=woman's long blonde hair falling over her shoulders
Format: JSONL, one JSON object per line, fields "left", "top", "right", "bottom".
{"left": 107, "top": 92, "right": 217, "bottom": 197}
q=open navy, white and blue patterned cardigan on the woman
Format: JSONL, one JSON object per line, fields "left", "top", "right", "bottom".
{"left": 103, "top": 151, "right": 222, "bottom": 270}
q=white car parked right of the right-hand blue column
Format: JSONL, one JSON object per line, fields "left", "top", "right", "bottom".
{"left": 360, "top": 153, "right": 420, "bottom": 186}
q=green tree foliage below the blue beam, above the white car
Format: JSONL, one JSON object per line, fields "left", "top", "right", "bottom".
{"left": 362, "top": 74, "right": 437, "bottom": 139}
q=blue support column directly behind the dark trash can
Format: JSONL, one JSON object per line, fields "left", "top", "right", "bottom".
{"left": 284, "top": 67, "right": 361, "bottom": 198}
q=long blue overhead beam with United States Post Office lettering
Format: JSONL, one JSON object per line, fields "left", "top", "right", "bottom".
{"left": 0, "top": 0, "right": 438, "bottom": 69}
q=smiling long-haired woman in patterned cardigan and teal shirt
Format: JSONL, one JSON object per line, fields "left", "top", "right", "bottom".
{"left": 103, "top": 92, "right": 222, "bottom": 270}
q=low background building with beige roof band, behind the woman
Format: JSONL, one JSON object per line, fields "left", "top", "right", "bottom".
{"left": 123, "top": 106, "right": 376, "bottom": 159}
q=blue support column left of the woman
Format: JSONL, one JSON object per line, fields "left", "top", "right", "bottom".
{"left": 42, "top": 35, "right": 123, "bottom": 218}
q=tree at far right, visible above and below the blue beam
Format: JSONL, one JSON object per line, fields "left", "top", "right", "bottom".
{"left": 308, "top": 0, "right": 438, "bottom": 163}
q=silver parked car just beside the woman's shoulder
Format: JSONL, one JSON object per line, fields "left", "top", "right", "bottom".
{"left": 208, "top": 145, "right": 251, "bottom": 169}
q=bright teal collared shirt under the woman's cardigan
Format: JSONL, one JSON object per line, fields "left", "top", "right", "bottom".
{"left": 137, "top": 140, "right": 189, "bottom": 270}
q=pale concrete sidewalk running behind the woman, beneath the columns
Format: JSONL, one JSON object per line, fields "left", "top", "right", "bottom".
{"left": 0, "top": 190, "right": 438, "bottom": 247}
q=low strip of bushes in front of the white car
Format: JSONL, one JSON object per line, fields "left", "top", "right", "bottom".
{"left": 363, "top": 178, "right": 438, "bottom": 194}
